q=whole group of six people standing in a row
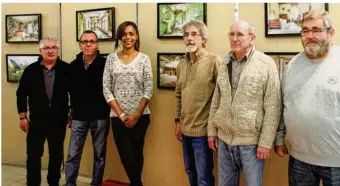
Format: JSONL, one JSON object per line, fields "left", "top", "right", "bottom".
{"left": 17, "top": 11, "right": 340, "bottom": 186}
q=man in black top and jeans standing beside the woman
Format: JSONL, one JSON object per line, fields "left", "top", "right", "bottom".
{"left": 65, "top": 31, "right": 110, "bottom": 186}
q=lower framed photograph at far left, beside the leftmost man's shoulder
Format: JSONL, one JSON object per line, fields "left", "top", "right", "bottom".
{"left": 6, "top": 54, "right": 39, "bottom": 82}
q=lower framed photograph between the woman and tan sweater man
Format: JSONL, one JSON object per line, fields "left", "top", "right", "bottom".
{"left": 157, "top": 53, "right": 185, "bottom": 90}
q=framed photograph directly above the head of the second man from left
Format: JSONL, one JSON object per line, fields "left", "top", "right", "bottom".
{"left": 76, "top": 7, "right": 115, "bottom": 41}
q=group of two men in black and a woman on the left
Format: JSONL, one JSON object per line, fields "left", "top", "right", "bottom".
{"left": 17, "top": 21, "right": 153, "bottom": 186}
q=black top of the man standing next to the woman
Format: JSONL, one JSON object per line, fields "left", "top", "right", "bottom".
{"left": 68, "top": 51, "right": 110, "bottom": 121}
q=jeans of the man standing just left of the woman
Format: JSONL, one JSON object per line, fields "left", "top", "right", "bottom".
{"left": 65, "top": 119, "right": 110, "bottom": 186}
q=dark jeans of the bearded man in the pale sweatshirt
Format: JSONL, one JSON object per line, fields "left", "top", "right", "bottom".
{"left": 288, "top": 156, "right": 340, "bottom": 186}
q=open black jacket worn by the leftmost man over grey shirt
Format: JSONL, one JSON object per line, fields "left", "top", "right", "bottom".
{"left": 17, "top": 56, "right": 69, "bottom": 126}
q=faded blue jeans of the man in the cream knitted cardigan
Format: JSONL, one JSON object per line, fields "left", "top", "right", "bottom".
{"left": 218, "top": 140, "right": 264, "bottom": 186}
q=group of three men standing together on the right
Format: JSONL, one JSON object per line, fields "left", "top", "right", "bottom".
{"left": 175, "top": 11, "right": 340, "bottom": 186}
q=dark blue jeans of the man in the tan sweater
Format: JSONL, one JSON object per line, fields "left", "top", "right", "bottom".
{"left": 182, "top": 134, "right": 215, "bottom": 186}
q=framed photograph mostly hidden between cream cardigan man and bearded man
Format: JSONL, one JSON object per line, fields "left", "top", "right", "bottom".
{"left": 265, "top": 52, "right": 299, "bottom": 80}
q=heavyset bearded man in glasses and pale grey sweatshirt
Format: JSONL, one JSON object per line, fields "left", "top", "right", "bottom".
{"left": 275, "top": 11, "right": 340, "bottom": 186}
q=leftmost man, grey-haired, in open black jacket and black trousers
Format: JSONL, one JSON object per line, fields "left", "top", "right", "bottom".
{"left": 17, "top": 37, "right": 69, "bottom": 186}
